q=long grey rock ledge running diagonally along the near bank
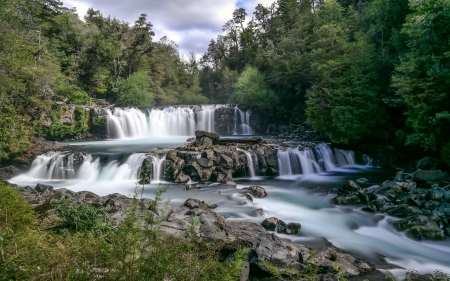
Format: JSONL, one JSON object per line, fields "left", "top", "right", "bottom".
{"left": 10, "top": 184, "right": 375, "bottom": 280}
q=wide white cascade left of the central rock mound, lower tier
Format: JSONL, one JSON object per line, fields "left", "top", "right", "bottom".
{"left": 25, "top": 152, "right": 146, "bottom": 182}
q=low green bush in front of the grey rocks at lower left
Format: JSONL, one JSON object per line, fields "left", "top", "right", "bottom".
{"left": 55, "top": 199, "right": 111, "bottom": 235}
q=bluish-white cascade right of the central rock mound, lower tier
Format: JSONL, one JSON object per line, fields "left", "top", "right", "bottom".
{"left": 277, "top": 143, "right": 355, "bottom": 176}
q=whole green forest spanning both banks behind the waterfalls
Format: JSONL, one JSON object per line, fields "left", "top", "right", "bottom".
{"left": 0, "top": 0, "right": 450, "bottom": 163}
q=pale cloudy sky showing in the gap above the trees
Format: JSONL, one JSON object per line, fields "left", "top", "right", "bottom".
{"left": 62, "top": 0, "right": 274, "bottom": 57}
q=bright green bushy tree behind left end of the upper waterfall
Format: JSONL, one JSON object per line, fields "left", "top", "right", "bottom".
{"left": 116, "top": 72, "right": 154, "bottom": 108}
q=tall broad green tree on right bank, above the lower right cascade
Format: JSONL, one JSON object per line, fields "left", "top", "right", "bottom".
{"left": 306, "top": 1, "right": 384, "bottom": 143}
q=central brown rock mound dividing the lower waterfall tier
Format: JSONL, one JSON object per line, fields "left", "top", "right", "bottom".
{"left": 157, "top": 131, "right": 278, "bottom": 183}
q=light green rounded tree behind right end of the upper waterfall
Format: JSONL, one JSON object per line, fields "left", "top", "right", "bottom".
{"left": 229, "top": 67, "right": 278, "bottom": 109}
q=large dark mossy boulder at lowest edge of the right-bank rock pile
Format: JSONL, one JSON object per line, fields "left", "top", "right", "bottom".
{"left": 394, "top": 215, "right": 445, "bottom": 238}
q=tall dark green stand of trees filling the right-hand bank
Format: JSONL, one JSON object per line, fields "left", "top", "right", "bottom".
{"left": 199, "top": 0, "right": 450, "bottom": 163}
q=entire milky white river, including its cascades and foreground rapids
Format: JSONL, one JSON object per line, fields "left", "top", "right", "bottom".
{"left": 7, "top": 108, "right": 450, "bottom": 279}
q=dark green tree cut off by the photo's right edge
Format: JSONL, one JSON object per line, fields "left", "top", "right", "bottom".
{"left": 393, "top": 0, "right": 450, "bottom": 164}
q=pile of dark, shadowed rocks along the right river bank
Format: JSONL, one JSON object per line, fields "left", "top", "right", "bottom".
{"left": 333, "top": 173, "right": 450, "bottom": 240}
